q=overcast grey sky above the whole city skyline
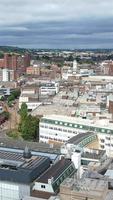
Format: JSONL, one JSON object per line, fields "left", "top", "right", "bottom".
{"left": 0, "top": 0, "right": 113, "bottom": 49}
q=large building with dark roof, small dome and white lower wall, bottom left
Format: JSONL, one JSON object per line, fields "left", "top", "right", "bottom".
{"left": 0, "top": 147, "right": 50, "bottom": 200}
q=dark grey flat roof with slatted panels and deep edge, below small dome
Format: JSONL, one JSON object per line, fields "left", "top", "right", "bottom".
{"left": 0, "top": 151, "right": 50, "bottom": 183}
